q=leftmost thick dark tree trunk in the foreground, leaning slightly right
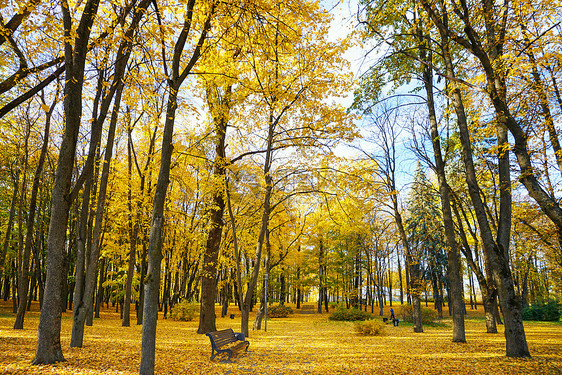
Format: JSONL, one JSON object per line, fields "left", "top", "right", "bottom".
{"left": 33, "top": 0, "right": 99, "bottom": 364}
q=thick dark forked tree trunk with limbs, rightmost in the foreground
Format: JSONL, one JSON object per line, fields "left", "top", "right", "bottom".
{"left": 420, "top": 0, "right": 528, "bottom": 357}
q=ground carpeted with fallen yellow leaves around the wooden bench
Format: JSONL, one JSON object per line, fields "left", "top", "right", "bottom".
{"left": 0, "top": 301, "right": 562, "bottom": 375}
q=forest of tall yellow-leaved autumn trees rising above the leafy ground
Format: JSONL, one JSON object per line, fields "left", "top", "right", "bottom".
{"left": 0, "top": 0, "right": 562, "bottom": 373}
